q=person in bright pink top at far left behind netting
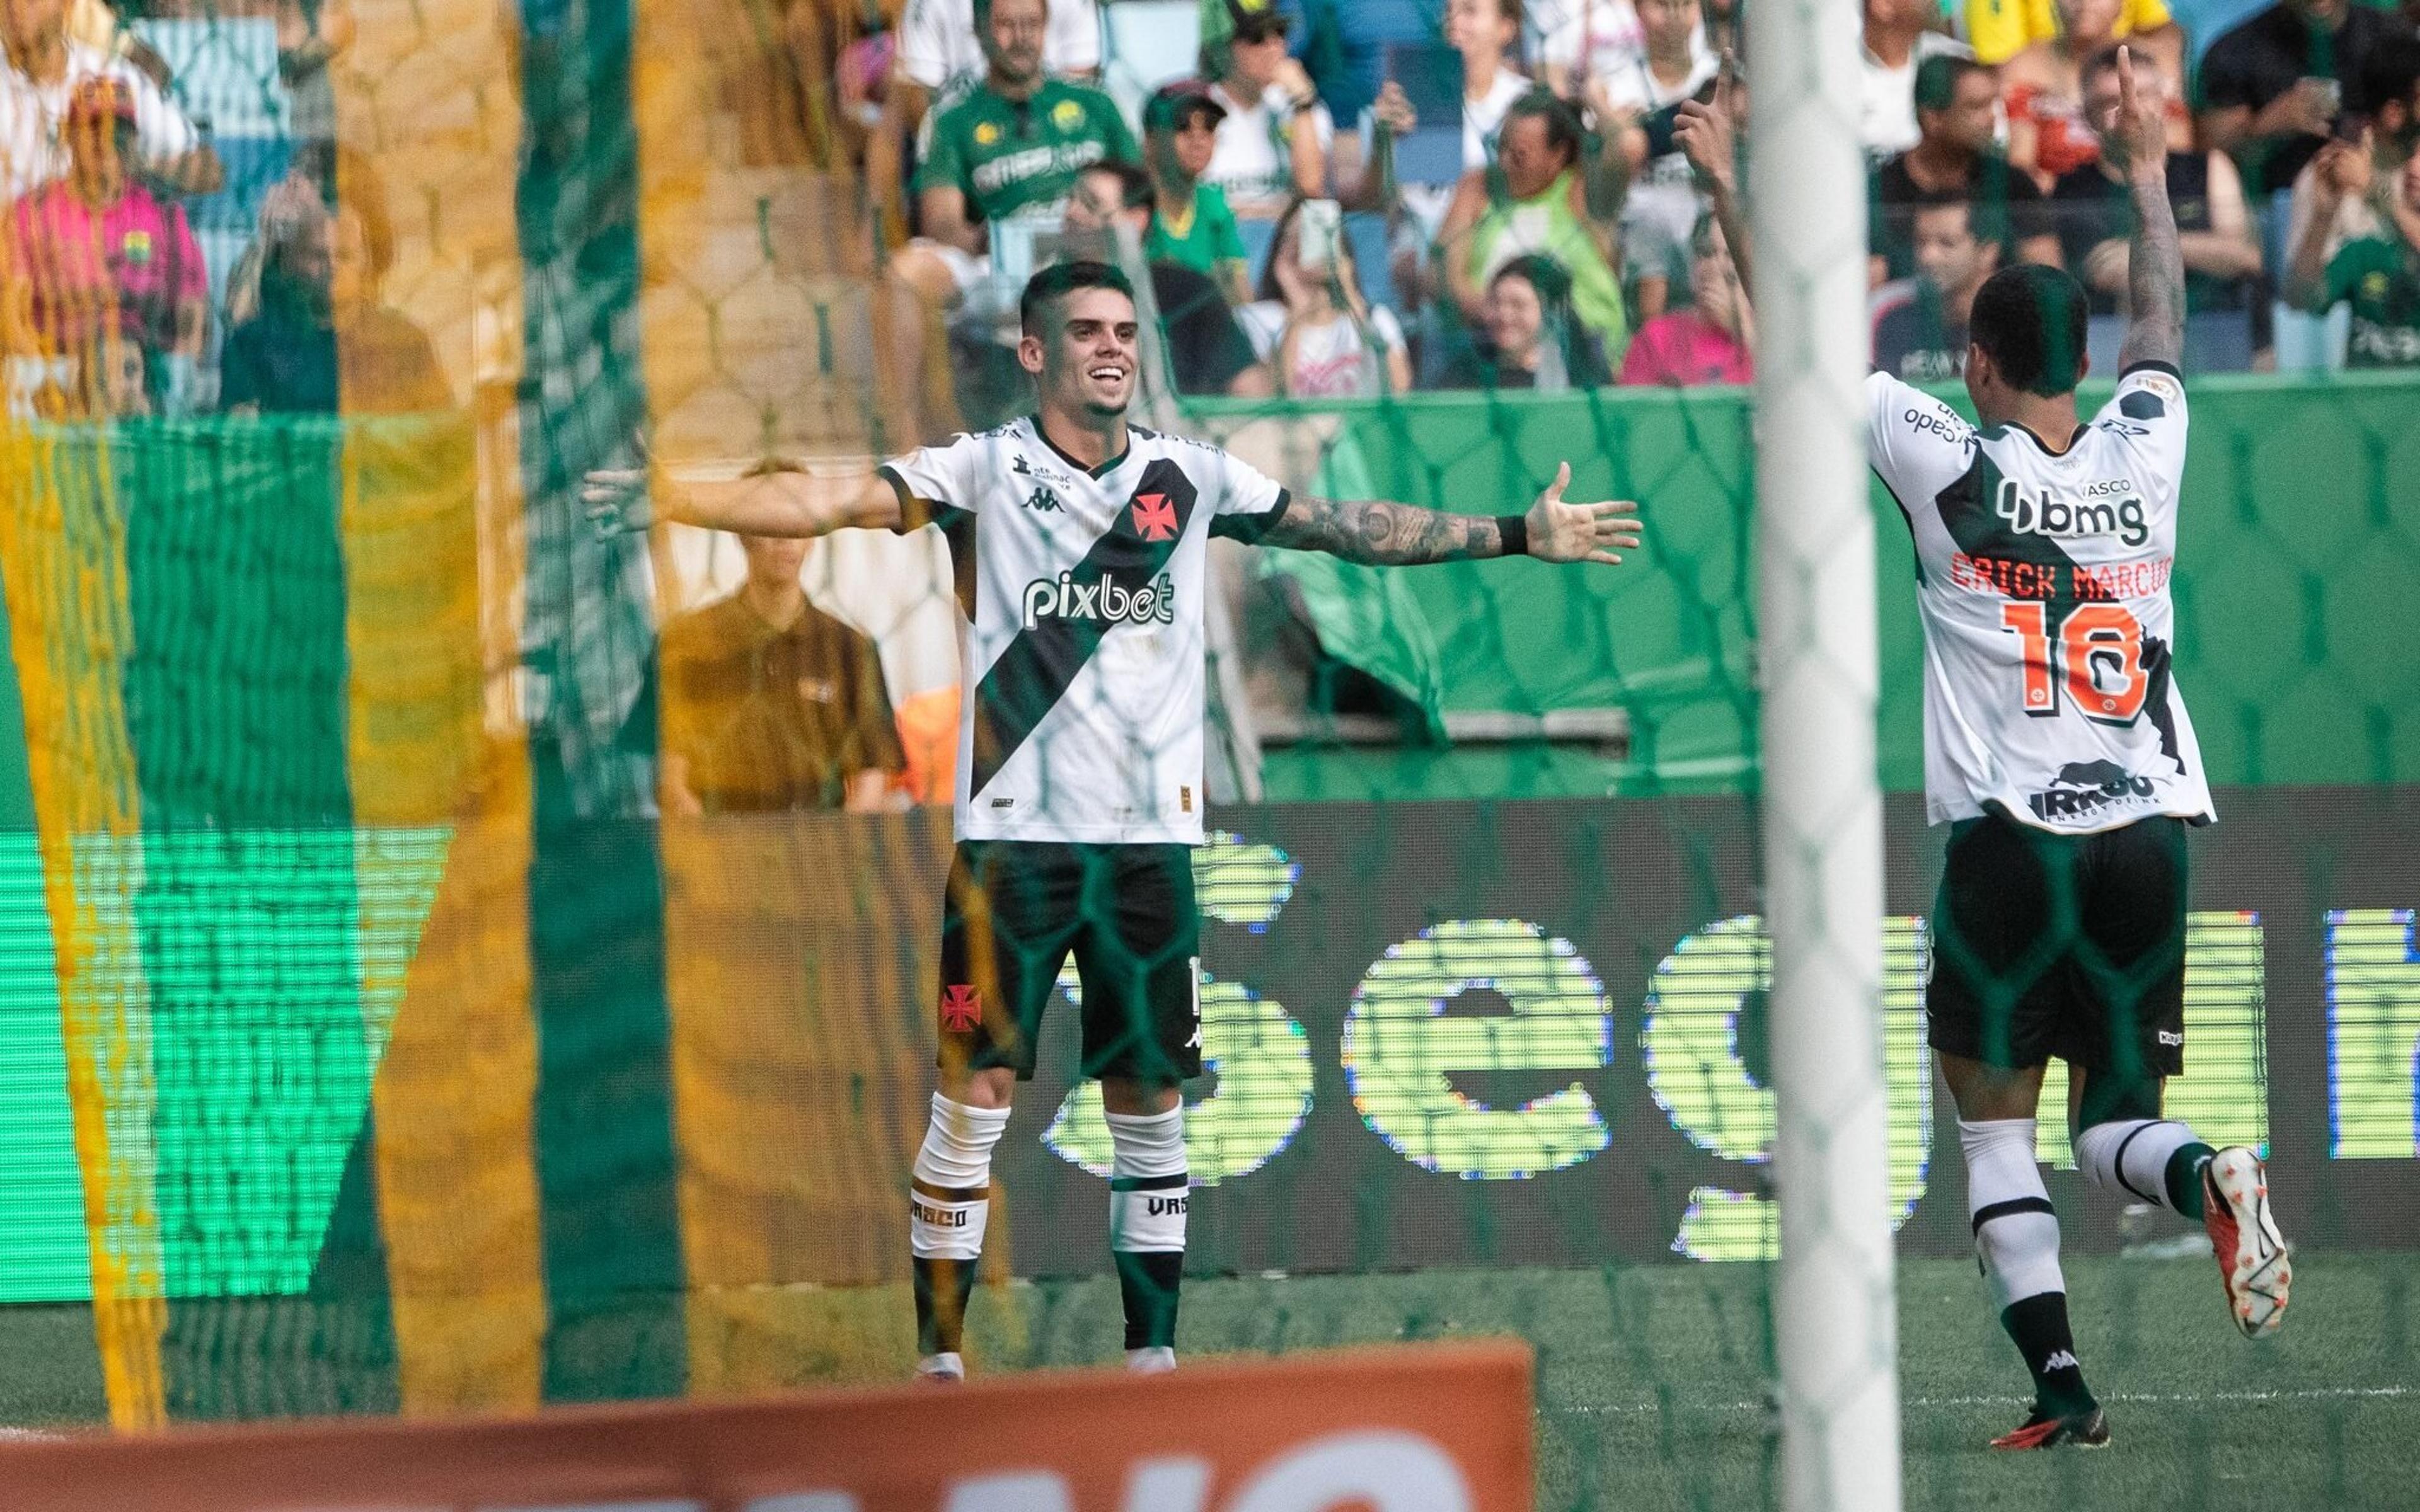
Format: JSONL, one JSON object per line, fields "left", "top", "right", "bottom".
{"left": 5, "top": 75, "right": 210, "bottom": 416}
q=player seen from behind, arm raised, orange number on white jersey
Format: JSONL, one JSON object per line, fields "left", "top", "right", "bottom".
{"left": 1866, "top": 53, "right": 2290, "bottom": 1449}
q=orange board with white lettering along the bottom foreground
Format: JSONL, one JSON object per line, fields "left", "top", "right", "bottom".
{"left": 0, "top": 1343, "right": 1530, "bottom": 1512}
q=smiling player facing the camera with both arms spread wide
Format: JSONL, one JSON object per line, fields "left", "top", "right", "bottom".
{"left": 638, "top": 261, "right": 1639, "bottom": 1379}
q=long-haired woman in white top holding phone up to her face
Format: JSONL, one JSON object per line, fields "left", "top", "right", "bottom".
{"left": 1244, "top": 201, "right": 1411, "bottom": 399}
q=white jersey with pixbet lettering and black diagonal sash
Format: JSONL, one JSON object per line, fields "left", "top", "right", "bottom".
{"left": 881, "top": 418, "right": 1288, "bottom": 844}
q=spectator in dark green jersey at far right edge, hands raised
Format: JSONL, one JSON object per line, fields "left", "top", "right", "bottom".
{"left": 2285, "top": 140, "right": 2420, "bottom": 368}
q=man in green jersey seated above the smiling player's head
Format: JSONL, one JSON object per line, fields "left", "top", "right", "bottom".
{"left": 893, "top": 0, "right": 1142, "bottom": 310}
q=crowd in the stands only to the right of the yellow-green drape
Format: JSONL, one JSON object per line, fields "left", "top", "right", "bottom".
{"left": 837, "top": 0, "right": 2420, "bottom": 399}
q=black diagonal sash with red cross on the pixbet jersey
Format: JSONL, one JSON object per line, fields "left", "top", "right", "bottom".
{"left": 968, "top": 457, "right": 1196, "bottom": 796}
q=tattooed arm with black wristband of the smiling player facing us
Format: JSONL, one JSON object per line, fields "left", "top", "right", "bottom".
{"left": 1261, "top": 462, "right": 1639, "bottom": 566}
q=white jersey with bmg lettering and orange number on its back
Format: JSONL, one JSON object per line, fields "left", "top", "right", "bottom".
{"left": 1866, "top": 363, "right": 2216, "bottom": 835}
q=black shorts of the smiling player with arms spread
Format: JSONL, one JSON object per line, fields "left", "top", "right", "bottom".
{"left": 939, "top": 839, "right": 1202, "bottom": 1084}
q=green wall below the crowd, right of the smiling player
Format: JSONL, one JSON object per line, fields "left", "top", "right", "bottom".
{"left": 1196, "top": 375, "right": 2420, "bottom": 801}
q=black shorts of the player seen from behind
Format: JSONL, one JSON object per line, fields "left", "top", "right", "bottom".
{"left": 1924, "top": 813, "right": 2186, "bottom": 1108}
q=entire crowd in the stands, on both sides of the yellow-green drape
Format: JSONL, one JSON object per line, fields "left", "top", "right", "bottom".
{"left": 0, "top": 0, "right": 2420, "bottom": 416}
